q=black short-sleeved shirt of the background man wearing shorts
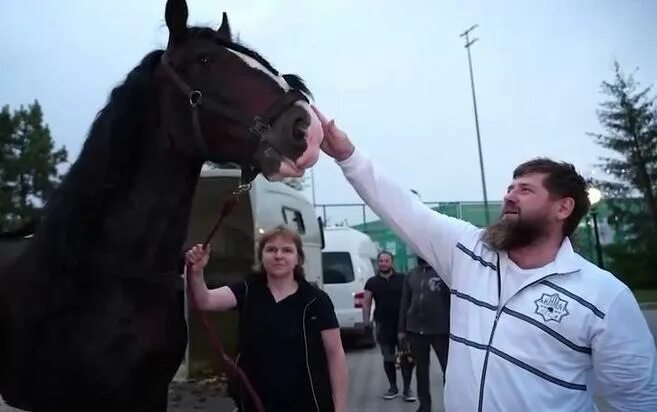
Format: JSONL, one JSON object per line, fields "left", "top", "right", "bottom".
{"left": 365, "top": 272, "right": 404, "bottom": 330}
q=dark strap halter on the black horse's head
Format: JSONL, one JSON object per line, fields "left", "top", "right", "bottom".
{"left": 161, "top": 52, "right": 308, "bottom": 187}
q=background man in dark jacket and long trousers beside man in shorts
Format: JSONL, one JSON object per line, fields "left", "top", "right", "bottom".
{"left": 399, "top": 256, "right": 450, "bottom": 412}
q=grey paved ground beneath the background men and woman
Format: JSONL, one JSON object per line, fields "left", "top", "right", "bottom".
{"left": 0, "top": 309, "right": 657, "bottom": 412}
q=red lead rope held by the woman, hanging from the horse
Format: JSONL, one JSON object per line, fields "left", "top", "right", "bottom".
{"left": 186, "top": 185, "right": 265, "bottom": 412}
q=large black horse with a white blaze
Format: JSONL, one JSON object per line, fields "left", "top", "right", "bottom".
{"left": 0, "top": 0, "right": 310, "bottom": 412}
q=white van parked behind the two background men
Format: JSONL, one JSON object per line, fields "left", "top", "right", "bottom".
{"left": 322, "top": 226, "right": 377, "bottom": 346}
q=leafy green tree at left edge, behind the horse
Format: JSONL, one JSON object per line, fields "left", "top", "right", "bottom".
{"left": 0, "top": 101, "right": 68, "bottom": 230}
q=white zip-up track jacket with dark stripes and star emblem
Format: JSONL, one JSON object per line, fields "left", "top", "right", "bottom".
{"left": 337, "top": 150, "right": 657, "bottom": 412}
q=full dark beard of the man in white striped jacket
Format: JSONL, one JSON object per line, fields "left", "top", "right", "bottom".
{"left": 483, "top": 214, "right": 546, "bottom": 252}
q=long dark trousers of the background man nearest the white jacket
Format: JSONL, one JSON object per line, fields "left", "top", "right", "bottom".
{"left": 406, "top": 332, "right": 449, "bottom": 412}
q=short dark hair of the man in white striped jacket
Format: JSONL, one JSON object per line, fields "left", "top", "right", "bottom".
{"left": 513, "top": 157, "right": 591, "bottom": 236}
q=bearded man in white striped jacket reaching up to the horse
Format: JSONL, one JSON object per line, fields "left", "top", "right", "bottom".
{"left": 312, "top": 108, "right": 657, "bottom": 412}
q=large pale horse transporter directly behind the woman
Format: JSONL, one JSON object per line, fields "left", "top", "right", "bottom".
{"left": 178, "top": 168, "right": 324, "bottom": 378}
